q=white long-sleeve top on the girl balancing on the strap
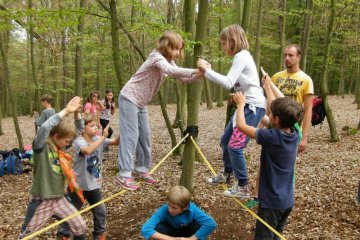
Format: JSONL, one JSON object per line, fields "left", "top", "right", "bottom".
{"left": 205, "top": 50, "right": 266, "bottom": 110}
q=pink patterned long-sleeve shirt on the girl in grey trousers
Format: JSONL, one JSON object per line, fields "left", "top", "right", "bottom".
{"left": 120, "top": 50, "right": 199, "bottom": 107}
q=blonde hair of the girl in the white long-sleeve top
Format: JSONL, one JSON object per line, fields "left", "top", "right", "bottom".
{"left": 220, "top": 24, "right": 249, "bottom": 55}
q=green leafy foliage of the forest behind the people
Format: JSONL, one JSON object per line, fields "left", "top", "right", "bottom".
{"left": 0, "top": 0, "right": 360, "bottom": 116}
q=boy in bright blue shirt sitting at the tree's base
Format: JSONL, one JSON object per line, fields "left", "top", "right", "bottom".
{"left": 141, "top": 186, "right": 216, "bottom": 240}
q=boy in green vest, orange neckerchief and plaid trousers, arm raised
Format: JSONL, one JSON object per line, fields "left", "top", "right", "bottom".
{"left": 19, "top": 97, "right": 86, "bottom": 239}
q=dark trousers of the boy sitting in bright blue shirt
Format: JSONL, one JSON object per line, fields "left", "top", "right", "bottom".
{"left": 155, "top": 222, "right": 200, "bottom": 237}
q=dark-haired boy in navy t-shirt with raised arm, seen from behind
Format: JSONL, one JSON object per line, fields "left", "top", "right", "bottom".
{"left": 234, "top": 92, "right": 304, "bottom": 239}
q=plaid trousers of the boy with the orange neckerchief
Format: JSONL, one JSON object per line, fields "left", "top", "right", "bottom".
{"left": 19, "top": 197, "right": 86, "bottom": 240}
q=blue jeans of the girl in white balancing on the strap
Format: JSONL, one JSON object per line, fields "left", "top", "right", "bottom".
{"left": 220, "top": 104, "right": 265, "bottom": 186}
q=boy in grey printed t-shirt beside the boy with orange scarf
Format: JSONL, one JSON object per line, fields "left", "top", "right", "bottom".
{"left": 59, "top": 113, "right": 119, "bottom": 240}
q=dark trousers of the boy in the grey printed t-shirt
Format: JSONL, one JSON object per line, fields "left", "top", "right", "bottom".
{"left": 59, "top": 189, "right": 106, "bottom": 237}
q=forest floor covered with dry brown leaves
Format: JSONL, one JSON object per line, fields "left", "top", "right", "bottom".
{"left": 0, "top": 95, "right": 360, "bottom": 240}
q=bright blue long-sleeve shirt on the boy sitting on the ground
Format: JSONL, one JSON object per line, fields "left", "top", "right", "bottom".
{"left": 141, "top": 202, "right": 216, "bottom": 240}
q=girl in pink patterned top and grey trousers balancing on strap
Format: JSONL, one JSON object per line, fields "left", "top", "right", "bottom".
{"left": 115, "top": 30, "right": 202, "bottom": 190}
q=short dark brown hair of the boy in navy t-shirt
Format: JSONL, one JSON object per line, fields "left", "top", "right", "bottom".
{"left": 270, "top": 97, "right": 304, "bottom": 128}
